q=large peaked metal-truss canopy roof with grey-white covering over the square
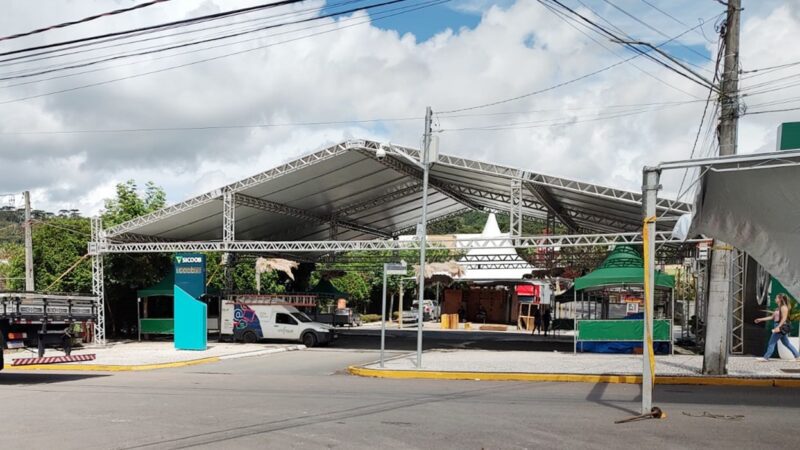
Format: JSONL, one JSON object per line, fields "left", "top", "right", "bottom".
{"left": 105, "top": 141, "right": 690, "bottom": 248}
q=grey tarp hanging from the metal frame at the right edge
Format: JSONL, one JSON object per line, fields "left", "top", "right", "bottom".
{"left": 689, "top": 165, "right": 800, "bottom": 298}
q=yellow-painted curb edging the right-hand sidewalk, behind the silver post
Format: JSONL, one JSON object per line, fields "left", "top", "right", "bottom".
{"left": 347, "top": 366, "right": 800, "bottom": 388}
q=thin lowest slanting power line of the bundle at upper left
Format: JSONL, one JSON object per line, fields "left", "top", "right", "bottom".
{"left": 0, "top": 0, "right": 440, "bottom": 105}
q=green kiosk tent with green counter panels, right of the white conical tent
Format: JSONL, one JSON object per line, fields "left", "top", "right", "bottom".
{"left": 573, "top": 246, "right": 675, "bottom": 353}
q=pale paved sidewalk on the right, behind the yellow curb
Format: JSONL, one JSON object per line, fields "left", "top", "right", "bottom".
{"left": 364, "top": 350, "right": 800, "bottom": 379}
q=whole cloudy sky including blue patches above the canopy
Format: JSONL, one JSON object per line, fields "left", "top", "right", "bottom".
{"left": 0, "top": 0, "right": 800, "bottom": 214}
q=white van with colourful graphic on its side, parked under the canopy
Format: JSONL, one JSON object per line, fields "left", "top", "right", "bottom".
{"left": 222, "top": 300, "right": 337, "bottom": 347}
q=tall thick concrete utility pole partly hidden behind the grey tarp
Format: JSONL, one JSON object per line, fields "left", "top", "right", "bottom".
{"left": 703, "top": 0, "right": 742, "bottom": 375}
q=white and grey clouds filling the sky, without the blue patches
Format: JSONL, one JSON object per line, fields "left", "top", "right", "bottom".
{"left": 0, "top": 0, "right": 800, "bottom": 216}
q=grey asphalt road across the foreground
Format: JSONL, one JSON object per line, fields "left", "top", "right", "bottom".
{"left": 0, "top": 349, "right": 800, "bottom": 449}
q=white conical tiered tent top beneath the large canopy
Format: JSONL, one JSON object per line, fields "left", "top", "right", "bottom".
{"left": 456, "top": 213, "right": 534, "bottom": 281}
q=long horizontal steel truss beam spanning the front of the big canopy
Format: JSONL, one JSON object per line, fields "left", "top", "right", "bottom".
{"left": 95, "top": 231, "right": 706, "bottom": 253}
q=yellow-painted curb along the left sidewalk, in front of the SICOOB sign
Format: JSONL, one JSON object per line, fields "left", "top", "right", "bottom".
{"left": 5, "top": 345, "right": 306, "bottom": 372}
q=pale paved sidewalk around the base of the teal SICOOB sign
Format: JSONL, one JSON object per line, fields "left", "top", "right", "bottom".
{"left": 5, "top": 341, "right": 305, "bottom": 370}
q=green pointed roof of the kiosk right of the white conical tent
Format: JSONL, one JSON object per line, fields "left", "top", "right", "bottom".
{"left": 575, "top": 246, "right": 675, "bottom": 291}
